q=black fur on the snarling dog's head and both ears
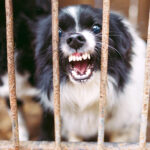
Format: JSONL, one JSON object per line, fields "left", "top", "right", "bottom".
{"left": 36, "top": 5, "right": 133, "bottom": 99}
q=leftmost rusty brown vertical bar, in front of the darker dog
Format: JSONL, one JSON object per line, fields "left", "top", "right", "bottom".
{"left": 5, "top": 0, "right": 19, "bottom": 150}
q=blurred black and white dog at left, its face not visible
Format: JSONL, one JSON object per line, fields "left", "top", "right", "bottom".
{"left": 0, "top": 0, "right": 50, "bottom": 140}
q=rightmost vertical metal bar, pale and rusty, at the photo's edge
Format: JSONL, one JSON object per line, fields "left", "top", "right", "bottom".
{"left": 140, "top": 11, "right": 150, "bottom": 150}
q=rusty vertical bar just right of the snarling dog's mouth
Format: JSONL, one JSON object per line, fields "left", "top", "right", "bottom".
{"left": 98, "top": 0, "right": 110, "bottom": 150}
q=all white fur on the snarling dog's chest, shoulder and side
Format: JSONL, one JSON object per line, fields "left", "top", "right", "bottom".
{"left": 42, "top": 17, "right": 146, "bottom": 142}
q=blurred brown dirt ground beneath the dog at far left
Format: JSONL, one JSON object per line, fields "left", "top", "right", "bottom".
{"left": 0, "top": 99, "right": 42, "bottom": 140}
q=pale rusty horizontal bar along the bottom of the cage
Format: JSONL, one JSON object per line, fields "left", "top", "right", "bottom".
{"left": 0, "top": 141, "right": 150, "bottom": 150}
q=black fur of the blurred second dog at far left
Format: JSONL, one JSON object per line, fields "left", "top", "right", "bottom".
{"left": 0, "top": 0, "right": 50, "bottom": 85}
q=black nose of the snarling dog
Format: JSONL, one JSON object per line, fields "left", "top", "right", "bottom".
{"left": 67, "top": 33, "right": 86, "bottom": 50}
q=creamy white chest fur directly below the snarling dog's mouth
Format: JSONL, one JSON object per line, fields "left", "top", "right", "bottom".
{"left": 61, "top": 72, "right": 115, "bottom": 137}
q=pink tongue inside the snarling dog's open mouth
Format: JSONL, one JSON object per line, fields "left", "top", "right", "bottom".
{"left": 73, "top": 60, "right": 88, "bottom": 75}
